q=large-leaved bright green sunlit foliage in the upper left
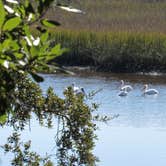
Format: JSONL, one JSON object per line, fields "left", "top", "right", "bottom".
{"left": 0, "top": 0, "right": 65, "bottom": 115}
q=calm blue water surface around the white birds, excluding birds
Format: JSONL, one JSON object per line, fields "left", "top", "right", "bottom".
{"left": 0, "top": 74, "right": 166, "bottom": 166}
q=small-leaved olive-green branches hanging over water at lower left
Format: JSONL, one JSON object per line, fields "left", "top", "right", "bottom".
{"left": 0, "top": 76, "right": 101, "bottom": 166}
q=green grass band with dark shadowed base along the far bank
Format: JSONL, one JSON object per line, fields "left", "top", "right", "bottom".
{"left": 52, "top": 30, "right": 166, "bottom": 72}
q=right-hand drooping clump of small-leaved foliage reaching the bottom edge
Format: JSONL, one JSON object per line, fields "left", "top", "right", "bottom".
{"left": 57, "top": 87, "right": 97, "bottom": 166}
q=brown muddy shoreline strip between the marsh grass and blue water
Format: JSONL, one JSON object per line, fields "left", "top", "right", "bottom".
{"left": 40, "top": 66, "right": 166, "bottom": 85}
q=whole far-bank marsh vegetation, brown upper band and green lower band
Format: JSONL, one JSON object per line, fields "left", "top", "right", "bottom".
{"left": 47, "top": 0, "right": 166, "bottom": 72}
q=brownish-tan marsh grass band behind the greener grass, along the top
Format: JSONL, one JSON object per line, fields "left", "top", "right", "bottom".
{"left": 47, "top": 0, "right": 166, "bottom": 32}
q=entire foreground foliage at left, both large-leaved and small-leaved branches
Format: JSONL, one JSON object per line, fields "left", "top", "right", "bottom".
{"left": 0, "top": 0, "right": 107, "bottom": 166}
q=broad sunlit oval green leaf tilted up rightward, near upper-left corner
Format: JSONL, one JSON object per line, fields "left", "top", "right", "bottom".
{"left": 3, "top": 17, "right": 21, "bottom": 31}
